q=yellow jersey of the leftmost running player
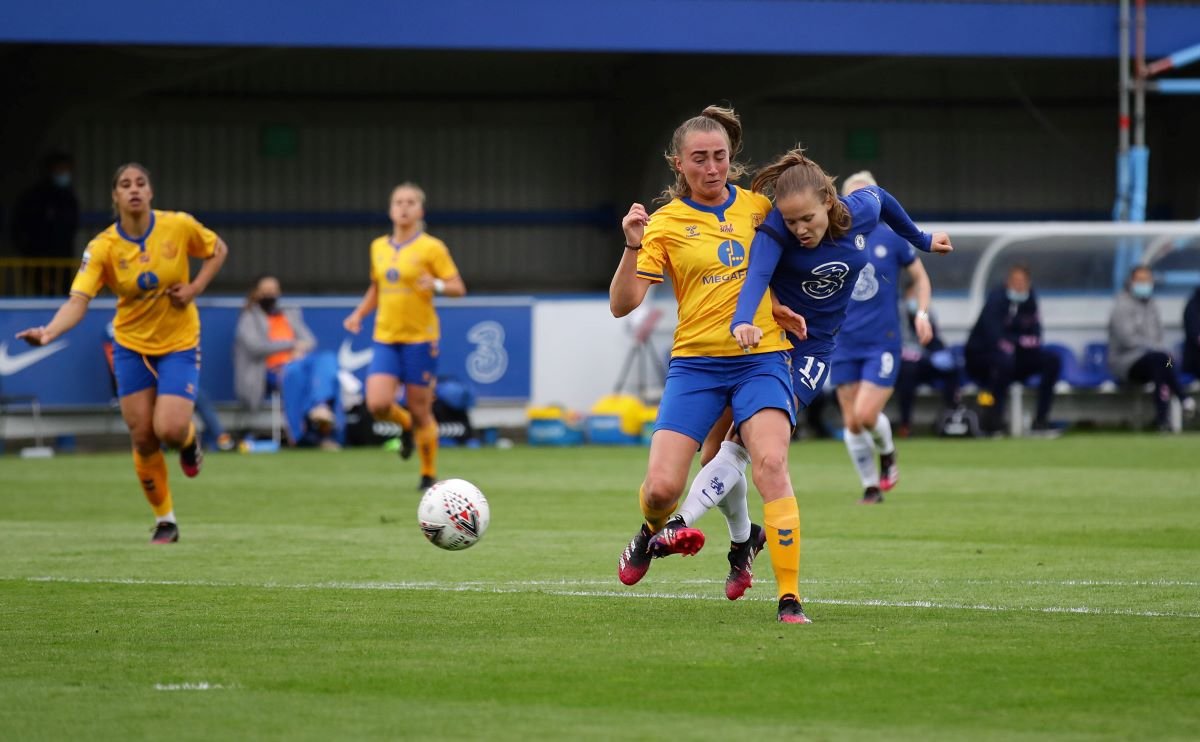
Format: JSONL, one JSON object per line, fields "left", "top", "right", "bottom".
{"left": 71, "top": 211, "right": 217, "bottom": 355}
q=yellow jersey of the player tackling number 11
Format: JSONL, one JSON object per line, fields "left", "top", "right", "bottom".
{"left": 637, "top": 185, "right": 792, "bottom": 357}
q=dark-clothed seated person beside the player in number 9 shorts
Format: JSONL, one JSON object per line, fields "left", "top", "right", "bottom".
{"left": 896, "top": 283, "right": 960, "bottom": 437}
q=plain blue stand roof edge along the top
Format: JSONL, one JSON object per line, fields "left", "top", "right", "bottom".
{"left": 7, "top": 0, "right": 1200, "bottom": 58}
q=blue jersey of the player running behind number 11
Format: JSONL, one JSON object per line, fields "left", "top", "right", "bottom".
{"left": 835, "top": 225, "right": 917, "bottom": 359}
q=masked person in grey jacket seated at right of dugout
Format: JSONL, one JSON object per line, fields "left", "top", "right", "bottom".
{"left": 1109, "top": 265, "right": 1195, "bottom": 431}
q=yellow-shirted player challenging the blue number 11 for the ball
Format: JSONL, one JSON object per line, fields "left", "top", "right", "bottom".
{"left": 608, "top": 106, "right": 803, "bottom": 622}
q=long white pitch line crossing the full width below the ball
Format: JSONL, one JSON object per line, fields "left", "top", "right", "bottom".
{"left": 11, "top": 576, "right": 1200, "bottom": 618}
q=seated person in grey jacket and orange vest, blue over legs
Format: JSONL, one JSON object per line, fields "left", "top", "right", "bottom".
{"left": 234, "top": 275, "right": 344, "bottom": 449}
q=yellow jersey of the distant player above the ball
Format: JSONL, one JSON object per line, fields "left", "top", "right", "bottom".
{"left": 371, "top": 232, "right": 458, "bottom": 343}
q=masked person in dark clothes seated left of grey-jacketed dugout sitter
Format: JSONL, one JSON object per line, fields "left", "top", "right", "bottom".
{"left": 966, "top": 265, "right": 1062, "bottom": 435}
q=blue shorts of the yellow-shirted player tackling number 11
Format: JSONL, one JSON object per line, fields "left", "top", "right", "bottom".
{"left": 654, "top": 351, "right": 796, "bottom": 445}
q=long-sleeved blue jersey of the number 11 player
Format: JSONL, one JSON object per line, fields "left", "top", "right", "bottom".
{"left": 730, "top": 186, "right": 932, "bottom": 358}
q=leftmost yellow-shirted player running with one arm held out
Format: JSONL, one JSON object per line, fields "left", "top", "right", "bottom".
{"left": 17, "top": 163, "right": 228, "bottom": 544}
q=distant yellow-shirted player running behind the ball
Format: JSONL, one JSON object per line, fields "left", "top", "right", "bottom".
{"left": 342, "top": 182, "right": 467, "bottom": 490}
